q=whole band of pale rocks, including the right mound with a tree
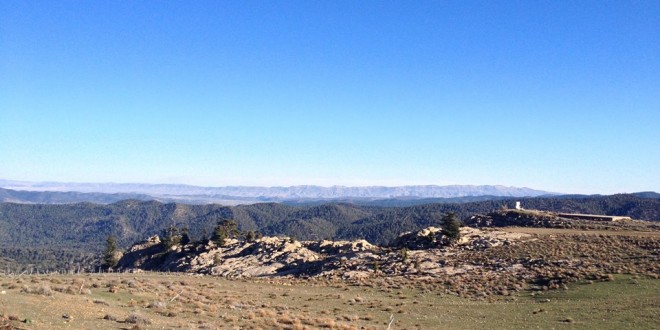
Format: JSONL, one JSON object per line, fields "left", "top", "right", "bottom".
{"left": 120, "top": 227, "right": 523, "bottom": 278}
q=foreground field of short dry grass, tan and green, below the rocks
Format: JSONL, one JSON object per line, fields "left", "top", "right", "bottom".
{"left": 0, "top": 273, "right": 660, "bottom": 329}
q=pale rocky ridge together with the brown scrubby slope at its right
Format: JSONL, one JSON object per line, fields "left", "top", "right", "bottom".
{"left": 120, "top": 227, "right": 660, "bottom": 299}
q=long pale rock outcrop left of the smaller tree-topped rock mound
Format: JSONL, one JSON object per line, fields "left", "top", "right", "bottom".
{"left": 119, "top": 237, "right": 380, "bottom": 277}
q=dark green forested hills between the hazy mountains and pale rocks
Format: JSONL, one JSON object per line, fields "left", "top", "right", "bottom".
{"left": 0, "top": 195, "right": 660, "bottom": 270}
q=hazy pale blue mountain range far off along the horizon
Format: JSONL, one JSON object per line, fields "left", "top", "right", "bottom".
{"left": 0, "top": 180, "right": 557, "bottom": 205}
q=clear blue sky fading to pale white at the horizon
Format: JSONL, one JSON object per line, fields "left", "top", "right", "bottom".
{"left": 0, "top": 0, "right": 660, "bottom": 193}
